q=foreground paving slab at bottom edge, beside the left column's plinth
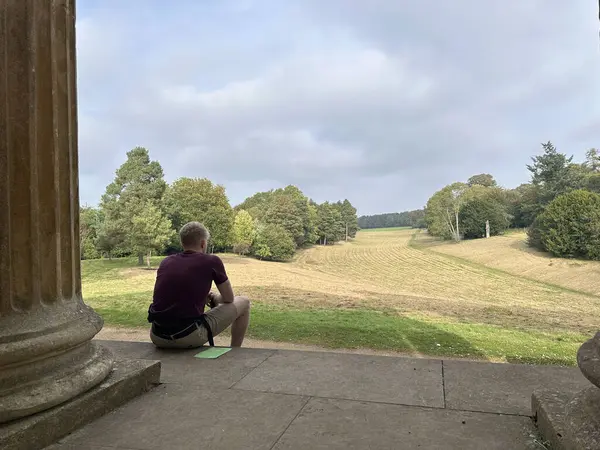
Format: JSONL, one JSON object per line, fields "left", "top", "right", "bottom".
{"left": 52, "top": 384, "right": 308, "bottom": 450}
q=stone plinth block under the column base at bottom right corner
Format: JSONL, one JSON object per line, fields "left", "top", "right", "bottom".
{"left": 532, "top": 386, "right": 600, "bottom": 450}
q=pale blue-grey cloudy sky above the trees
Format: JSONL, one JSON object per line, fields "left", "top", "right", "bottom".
{"left": 77, "top": 0, "right": 600, "bottom": 214}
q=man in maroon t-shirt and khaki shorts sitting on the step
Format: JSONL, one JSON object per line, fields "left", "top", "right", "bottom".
{"left": 148, "top": 222, "right": 250, "bottom": 348}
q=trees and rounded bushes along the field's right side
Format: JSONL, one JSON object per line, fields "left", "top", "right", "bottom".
{"left": 425, "top": 142, "right": 600, "bottom": 259}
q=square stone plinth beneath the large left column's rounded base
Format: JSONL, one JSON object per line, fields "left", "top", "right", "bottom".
{"left": 0, "top": 360, "right": 160, "bottom": 450}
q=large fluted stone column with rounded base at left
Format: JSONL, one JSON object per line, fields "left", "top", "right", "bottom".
{"left": 0, "top": 0, "right": 112, "bottom": 423}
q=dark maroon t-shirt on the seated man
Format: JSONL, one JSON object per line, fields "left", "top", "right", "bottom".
{"left": 149, "top": 251, "right": 227, "bottom": 322}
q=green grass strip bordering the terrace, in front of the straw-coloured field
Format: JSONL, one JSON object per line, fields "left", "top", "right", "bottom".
{"left": 88, "top": 293, "right": 585, "bottom": 366}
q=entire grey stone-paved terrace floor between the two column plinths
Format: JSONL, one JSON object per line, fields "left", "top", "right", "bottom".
{"left": 50, "top": 341, "right": 588, "bottom": 450}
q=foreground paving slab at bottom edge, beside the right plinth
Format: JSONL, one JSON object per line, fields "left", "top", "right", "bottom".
{"left": 274, "top": 399, "right": 539, "bottom": 450}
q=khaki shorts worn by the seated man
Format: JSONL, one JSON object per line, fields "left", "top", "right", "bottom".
{"left": 150, "top": 303, "right": 237, "bottom": 348}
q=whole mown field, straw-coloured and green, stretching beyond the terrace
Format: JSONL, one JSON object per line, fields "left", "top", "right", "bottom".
{"left": 82, "top": 229, "right": 600, "bottom": 365}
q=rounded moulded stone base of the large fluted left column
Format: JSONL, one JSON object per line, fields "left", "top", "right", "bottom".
{"left": 0, "top": 299, "right": 113, "bottom": 424}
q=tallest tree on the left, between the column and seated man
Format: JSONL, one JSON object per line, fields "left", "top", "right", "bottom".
{"left": 100, "top": 147, "right": 167, "bottom": 264}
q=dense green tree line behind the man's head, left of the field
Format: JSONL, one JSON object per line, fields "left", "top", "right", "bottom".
{"left": 80, "top": 147, "right": 358, "bottom": 265}
